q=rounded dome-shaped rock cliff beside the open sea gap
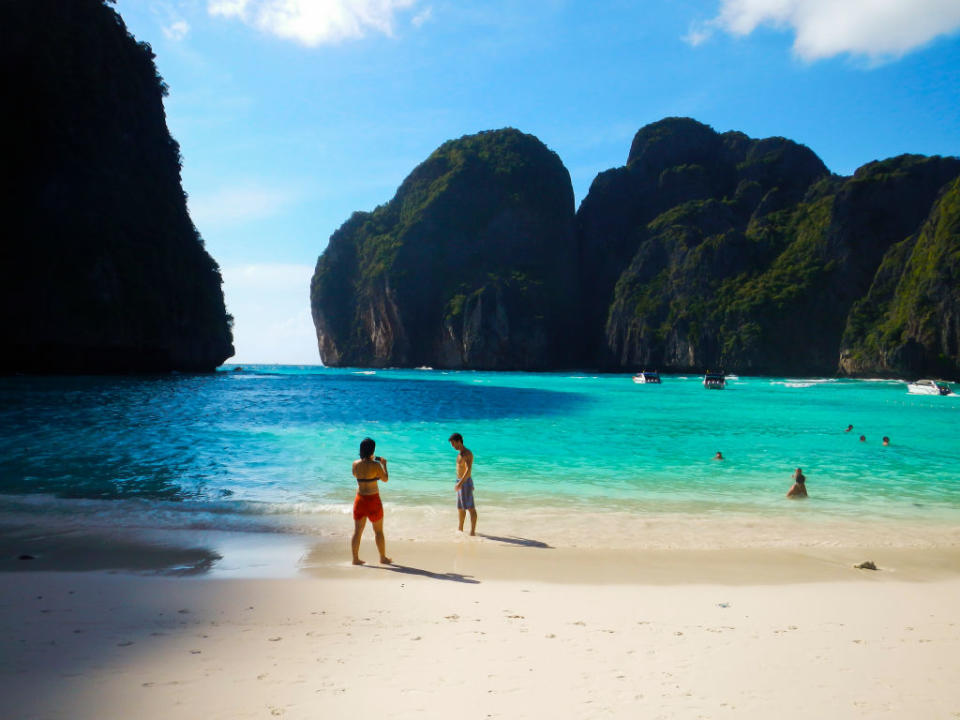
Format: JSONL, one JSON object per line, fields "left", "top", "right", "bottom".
{"left": 311, "top": 129, "right": 579, "bottom": 369}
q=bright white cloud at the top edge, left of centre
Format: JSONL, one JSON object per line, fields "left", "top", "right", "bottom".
{"left": 207, "top": 0, "right": 419, "bottom": 47}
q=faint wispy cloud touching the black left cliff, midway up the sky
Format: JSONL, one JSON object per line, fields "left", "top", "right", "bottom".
{"left": 189, "top": 183, "right": 302, "bottom": 233}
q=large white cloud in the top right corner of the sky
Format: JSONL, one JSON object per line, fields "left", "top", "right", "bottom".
{"left": 685, "top": 0, "right": 960, "bottom": 62}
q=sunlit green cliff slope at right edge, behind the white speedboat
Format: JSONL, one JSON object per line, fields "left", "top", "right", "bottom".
{"left": 840, "top": 179, "right": 960, "bottom": 378}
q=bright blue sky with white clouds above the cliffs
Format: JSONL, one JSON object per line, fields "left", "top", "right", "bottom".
{"left": 110, "top": 0, "right": 960, "bottom": 364}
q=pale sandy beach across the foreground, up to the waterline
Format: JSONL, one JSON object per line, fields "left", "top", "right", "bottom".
{"left": 0, "top": 534, "right": 960, "bottom": 720}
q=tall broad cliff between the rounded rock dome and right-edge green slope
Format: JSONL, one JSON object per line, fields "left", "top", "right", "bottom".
{"left": 577, "top": 118, "right": 960, "bottom": 375}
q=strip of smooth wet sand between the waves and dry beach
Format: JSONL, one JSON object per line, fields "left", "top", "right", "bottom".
{"left": 7, "top": 525, "right": 960, "bottom": 585}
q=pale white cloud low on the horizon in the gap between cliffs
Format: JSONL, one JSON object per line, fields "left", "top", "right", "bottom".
{"left": 221, "top": 263, "right": 320, "bottom": 365}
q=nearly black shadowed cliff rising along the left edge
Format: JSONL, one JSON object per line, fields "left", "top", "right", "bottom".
{"left": 0, "top": 0, "right": 233, "bottom": 372}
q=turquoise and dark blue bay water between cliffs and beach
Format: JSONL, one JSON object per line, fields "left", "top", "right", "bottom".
{"left": 0, "top": 366, "right": 960, "bottom": 544}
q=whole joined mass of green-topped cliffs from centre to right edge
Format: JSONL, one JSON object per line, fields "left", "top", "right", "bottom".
{"left": 312, "top": 118, "right": 960, "bottom": 377}
